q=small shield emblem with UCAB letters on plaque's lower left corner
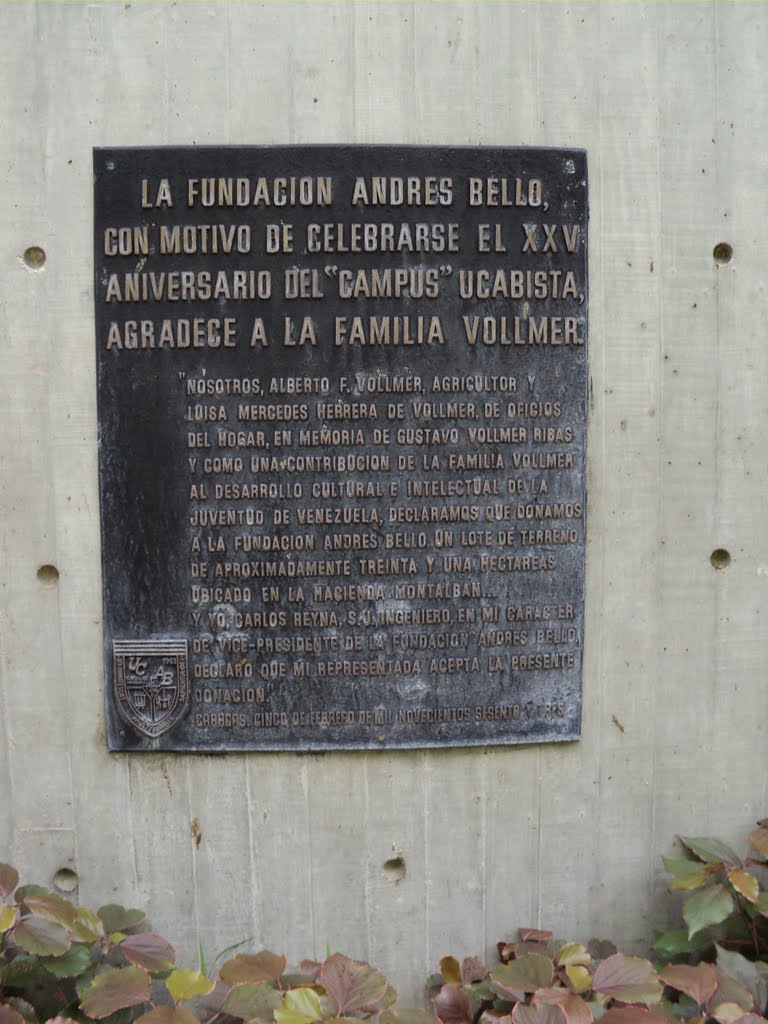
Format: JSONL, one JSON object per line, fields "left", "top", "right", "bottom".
{"left": 114, "top": 640, "right": 189, "bottom": 737}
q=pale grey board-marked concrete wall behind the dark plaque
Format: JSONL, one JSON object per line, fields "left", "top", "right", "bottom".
{"left": 0, "top": 0, "right": 768, "bottom": 999}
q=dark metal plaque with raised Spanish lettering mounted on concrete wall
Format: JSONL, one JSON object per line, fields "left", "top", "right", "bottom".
{"left": 94, "top": 146, "right": 587, "bottom": 752}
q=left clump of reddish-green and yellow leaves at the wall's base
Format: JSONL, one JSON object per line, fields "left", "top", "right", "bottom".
{"left": 0, "top": 864, "right": 417, "bottom": 1024}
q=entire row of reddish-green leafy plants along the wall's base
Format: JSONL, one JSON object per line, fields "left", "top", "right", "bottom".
{"left": 0, "top": 819, "right": 768, "bottom": 1024}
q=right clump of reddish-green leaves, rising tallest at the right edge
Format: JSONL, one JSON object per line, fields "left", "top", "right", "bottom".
{"left": 429, "top": 819, "right": 768, "bottom": 1024}
